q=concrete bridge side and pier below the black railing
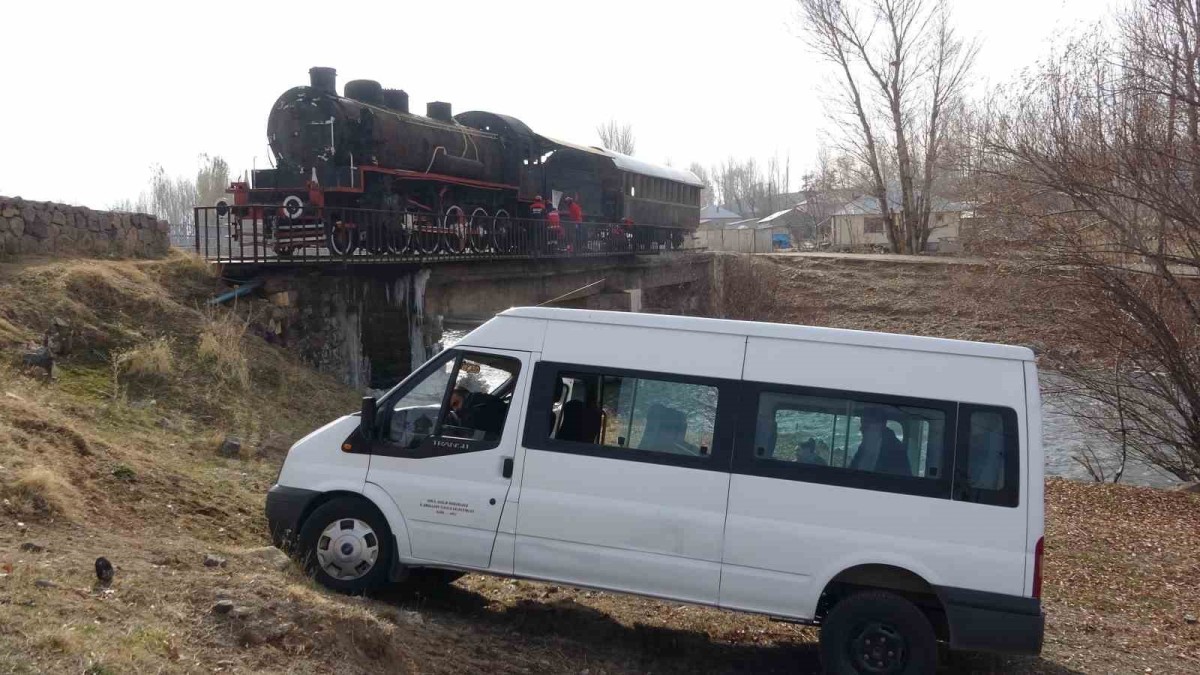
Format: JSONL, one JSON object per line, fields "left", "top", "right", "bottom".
{"left": 258, "top": 253, "right": 714, "bottom": 389}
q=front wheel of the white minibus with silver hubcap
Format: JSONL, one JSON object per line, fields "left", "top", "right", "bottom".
{"left": 300, "top": 497, "right": 392, "bottom": 593}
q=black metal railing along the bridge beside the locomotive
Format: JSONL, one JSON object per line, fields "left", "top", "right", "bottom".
{"left": 192, "top": 204, "right": 692, "bottom": 263}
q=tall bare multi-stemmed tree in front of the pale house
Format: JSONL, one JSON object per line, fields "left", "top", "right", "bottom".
{"left": 798, "top": 0, "right": 977, "bottom": 253}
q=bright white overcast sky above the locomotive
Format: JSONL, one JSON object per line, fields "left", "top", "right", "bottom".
{"left": 0, "top": 0, "right": 1110, "bottom": 208}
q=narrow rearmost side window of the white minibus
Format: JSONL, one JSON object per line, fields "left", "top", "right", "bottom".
{"left": 954, "top": 405, "right": 1020, "bottom": 507}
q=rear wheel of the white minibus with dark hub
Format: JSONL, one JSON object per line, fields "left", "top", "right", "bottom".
{"left": 821, "top": 591, "right": 937, "bottom": 675}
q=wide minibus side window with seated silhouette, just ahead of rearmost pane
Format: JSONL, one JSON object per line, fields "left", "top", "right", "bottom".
{"left": 754, "top": 392, "right": 947, "bottom": 480}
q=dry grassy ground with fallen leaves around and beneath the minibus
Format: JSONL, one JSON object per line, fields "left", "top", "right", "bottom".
{"left": 0, "top": 257, "right": 1200, "bottom": 673}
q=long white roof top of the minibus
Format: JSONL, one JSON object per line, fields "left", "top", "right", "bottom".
{"left": 487, "top": 307, "right": 1033, "bottom": 362}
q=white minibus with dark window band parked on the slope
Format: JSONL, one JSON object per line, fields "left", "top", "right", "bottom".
{"left": 266, "top": 307, "right": 1044, "bottom": 673}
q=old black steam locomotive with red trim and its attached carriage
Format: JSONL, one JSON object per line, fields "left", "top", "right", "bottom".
{"left": 226, "top": 67, "right": 702, "bottom": 255}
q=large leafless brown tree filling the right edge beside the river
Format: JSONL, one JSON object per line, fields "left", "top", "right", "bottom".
{"left": 982, "top": 0, "right": 1200, "bottom": 480}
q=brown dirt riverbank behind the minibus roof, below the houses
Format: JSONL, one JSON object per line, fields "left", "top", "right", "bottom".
{"left": 700, "top": 255, "right": 1087, "bottom": 368}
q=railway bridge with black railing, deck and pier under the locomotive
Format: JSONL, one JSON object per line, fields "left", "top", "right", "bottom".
{"left": 190, "top": 209, "right": 715, "bottom": 389}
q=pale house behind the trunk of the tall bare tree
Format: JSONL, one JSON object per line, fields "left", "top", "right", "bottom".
{"left": 829, "top": 193, "right": 966, "bottom": 252}
